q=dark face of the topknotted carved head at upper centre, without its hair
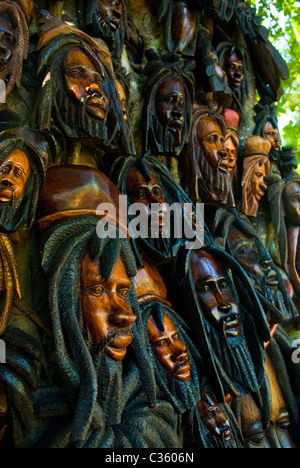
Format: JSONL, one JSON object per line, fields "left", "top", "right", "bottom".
{"left": 156, "top": 77, "right": 185, "bottom": 147}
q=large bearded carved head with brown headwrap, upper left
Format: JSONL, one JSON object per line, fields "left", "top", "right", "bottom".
{"left": 36, "top": 18, "right": 132, "bottom": 157}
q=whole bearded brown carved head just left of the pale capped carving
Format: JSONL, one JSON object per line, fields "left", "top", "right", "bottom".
{"left": 181, "top": 98, "right": 234, "bottom": 206}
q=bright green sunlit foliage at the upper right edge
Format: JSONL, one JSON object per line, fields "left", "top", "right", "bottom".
{"left": 250, "top": 0, "right": 300, "bottom": 162}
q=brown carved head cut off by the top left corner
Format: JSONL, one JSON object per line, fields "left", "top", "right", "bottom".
{"left": 0, "top": 0, "right": 33, "bottom": 95}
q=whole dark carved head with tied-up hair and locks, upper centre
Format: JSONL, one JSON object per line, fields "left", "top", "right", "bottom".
{"left": 144, "top": 55, "right": 194, "bottom": 156}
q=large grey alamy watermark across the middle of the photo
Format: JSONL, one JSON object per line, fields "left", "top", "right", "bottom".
{"left": 97, "top": 195, "right": 204, "bottom": 249}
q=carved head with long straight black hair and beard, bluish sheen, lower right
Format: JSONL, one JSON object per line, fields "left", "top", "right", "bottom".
{"left": 174, "top": 245, "right": 270, "bottom": 398}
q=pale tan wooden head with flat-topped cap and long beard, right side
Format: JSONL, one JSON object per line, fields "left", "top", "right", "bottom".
{"left": 242, "top": 135, "right": 271, "bottom": 218}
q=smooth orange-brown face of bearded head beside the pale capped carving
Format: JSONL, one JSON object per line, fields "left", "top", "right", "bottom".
{"left": 198, "top": 118, "right": 229, "bottom": 173}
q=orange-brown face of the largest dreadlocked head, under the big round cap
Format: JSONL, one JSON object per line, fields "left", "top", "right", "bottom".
{"left": 81, "top": 254, "right": 136, "bottom": 361}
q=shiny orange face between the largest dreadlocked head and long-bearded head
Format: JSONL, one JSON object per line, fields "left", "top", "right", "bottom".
{"left": 148, "top": 314, "right": 191, "bottom": 382}
